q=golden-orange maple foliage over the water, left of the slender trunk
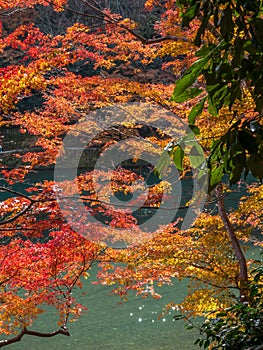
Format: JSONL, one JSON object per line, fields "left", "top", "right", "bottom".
{"left": 99, "top": 214, "right": 241, "bottom": 314}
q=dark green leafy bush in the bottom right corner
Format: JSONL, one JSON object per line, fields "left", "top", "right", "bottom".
{"left": 195, "top": 265, "right": 263, "bottom": 350}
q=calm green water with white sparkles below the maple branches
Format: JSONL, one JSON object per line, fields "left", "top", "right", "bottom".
{"left": 7, "top": 266, "right": 200, "bottom": 350}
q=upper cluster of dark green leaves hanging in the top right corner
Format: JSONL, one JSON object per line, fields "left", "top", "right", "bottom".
{"left": 172, "top": 0, "right": 263, "bottom": 117}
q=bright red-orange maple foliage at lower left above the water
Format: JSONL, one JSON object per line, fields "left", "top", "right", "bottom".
{"left": 0, "top": 231, "right": 99, "bottom": 334}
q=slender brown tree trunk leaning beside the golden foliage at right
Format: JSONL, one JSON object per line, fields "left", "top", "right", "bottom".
{"left": 215, "top": 183, "right": 248, "bottom": 301}
